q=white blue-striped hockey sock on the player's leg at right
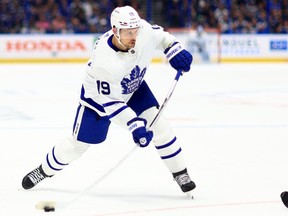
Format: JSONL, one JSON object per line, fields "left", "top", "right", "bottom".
{"left": 140, "top": 107, "right": 186, "bottom": 173}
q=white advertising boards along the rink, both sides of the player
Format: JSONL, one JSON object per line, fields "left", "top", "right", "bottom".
{"left": 0, "top": 31, "right": 288, "bottom": 63}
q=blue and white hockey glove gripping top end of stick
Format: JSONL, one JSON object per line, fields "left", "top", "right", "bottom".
{"left": 164, "top": 42, "right": 193, "bottom": 72}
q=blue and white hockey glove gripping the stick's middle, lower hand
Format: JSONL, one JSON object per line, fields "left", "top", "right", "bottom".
{"left": 127, "top": 118, "right": 153, "bottom": 147}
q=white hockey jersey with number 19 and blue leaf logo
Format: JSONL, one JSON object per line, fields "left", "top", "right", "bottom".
{"left": 80, "top": 20, "right": 176, "bottom": 126}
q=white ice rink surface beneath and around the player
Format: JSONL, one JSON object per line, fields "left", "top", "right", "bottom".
{"left": 0, "top": 64, "right": 288, "bottom": 216}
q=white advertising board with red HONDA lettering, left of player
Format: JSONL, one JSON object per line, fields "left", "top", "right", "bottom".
{"left": 0, "top": 35, "right": 96, "bottom": 62}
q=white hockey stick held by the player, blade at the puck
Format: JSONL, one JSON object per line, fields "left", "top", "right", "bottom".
{"left": 36, "top": 70, "right": 182, "bottom": 212}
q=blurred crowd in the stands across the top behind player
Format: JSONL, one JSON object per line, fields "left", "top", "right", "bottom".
{"left": 0, "top": 0, "right": 288, "bottom": 34}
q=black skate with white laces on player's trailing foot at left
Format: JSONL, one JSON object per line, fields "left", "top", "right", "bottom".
{"left": 22, "top": 165, "right": 52, "bottom": 190}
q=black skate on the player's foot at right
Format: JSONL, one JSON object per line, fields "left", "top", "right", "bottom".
{"left": 173, "top": 168, "right": 196, "bottom": 198}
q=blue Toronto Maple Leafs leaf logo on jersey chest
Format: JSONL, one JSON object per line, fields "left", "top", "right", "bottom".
{"left": 121, "top": 65, "right": 146, "bottom": 94}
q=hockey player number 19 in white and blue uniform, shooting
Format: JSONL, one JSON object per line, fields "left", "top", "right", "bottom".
{"left": 22, "top": 6, "right": 196, "bottom": 196}
